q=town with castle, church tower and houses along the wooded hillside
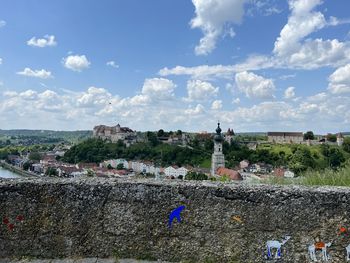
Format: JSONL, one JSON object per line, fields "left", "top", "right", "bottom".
{"left": 1, "top": 123, "right": 350, "bottom": 185}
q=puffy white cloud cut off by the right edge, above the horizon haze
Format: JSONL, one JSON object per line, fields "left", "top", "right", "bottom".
{"left": 328, "top": 64, "right": 350, "bottom": 94}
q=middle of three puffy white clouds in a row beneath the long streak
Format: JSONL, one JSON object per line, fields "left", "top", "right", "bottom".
{"left": 186, "top": 80, "right": 219, "bottom": 101}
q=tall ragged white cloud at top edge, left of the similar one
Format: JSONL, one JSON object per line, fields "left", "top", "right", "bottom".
{"left": 190, "top": 0, "right": 246, "bottom": 55}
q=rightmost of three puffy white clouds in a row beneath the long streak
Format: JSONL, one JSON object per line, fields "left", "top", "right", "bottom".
{"left": 235, "top": 71, "right": 275, "bottom": 99}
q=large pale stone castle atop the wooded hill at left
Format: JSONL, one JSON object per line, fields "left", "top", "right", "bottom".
{"left": 93, "top": 123, "right": 137, "bottom": 146}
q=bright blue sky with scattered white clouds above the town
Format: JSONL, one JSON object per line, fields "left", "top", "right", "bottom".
{"left": 0, "top": 0, "right": 350, "bottom": 134}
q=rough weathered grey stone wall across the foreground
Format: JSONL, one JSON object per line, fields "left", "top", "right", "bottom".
{"left": 0, "top": 178, "right": 350, "bottom": 263}
